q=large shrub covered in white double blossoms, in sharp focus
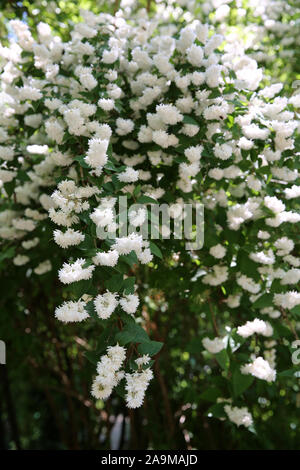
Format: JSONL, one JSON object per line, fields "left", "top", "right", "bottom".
{"left": 0, "top": 0, "right": 300, "bottom": 448}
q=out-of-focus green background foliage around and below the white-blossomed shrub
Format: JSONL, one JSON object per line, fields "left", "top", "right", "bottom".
{"left": 0, "top": 0, "right": 300, "bottom": 449}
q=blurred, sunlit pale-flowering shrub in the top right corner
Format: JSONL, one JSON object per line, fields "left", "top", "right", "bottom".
{"left": 183, "top": 0, "right": 299, "bottom": 85}
